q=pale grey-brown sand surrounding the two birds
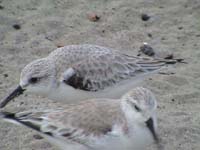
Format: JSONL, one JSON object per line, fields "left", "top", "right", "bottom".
{"left": 0, "top": 0, "right": 200, "bottom": 150}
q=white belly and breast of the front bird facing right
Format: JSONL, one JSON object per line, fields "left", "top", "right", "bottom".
{"left": 46, "top": 124, "right": 153, "bottom": 150}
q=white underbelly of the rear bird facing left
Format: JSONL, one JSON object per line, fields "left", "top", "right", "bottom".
{"left": 48, "top": 77, "right": 142, "bottom": 103}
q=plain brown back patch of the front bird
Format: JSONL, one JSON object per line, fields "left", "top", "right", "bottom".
{"left": 48, "top": 100, "right": 125, "bottom": 136}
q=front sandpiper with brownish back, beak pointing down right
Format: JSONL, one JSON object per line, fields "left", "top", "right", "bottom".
{"left": 0, "top": 87, "right": 160, "bottom": 150}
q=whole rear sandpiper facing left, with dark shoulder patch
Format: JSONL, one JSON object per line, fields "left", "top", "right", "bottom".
{"left": 0, "top": 45, "right": 175, "bottom": 108}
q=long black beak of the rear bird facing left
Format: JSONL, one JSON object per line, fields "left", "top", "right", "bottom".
{"left": 0, "top": 85, "right": 25, "bottom": 108}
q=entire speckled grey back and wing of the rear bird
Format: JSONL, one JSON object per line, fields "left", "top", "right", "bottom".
{"left": 49, "top": 45, "right": 165, "bottom": 91}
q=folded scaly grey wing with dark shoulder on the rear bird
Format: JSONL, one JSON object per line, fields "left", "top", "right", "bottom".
{"left": 61, "top": 54, "right": 164, "bottom": 91}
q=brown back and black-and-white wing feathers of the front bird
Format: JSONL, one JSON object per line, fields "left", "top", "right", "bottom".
{"left": 4, "top": 99, "right": 125, "bottom": 145}
